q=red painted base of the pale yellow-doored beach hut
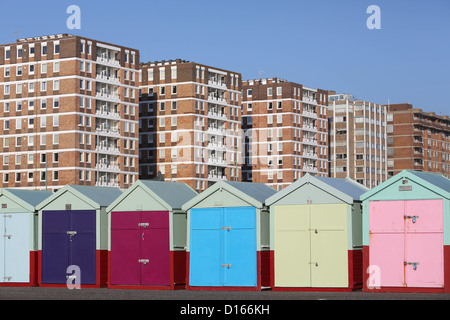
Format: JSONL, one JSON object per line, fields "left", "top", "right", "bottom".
{"left": 270, "top": 250, "right": 363, "bottom": 292}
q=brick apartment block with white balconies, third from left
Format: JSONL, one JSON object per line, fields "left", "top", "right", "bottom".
{"left": 242, "top": 78, "right": 329, "bottom": 190}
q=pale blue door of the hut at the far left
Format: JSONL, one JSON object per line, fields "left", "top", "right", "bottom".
{"left": 2, "top": 213, "right": 30, "bottom": 283}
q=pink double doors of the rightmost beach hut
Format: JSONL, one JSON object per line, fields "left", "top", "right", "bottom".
{"left": 369, "top": 200, "right": 444, "bottom": 288}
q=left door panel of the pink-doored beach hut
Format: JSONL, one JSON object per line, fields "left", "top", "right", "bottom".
{"left": 370, "top": 201, "right": 405, "bottom": 287}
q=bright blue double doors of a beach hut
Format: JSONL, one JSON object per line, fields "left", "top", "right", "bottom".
{"left": 189, "top": 207, "right": 257, "bottom": 287}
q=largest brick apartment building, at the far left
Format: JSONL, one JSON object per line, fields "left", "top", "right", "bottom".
{"left": 0, "top": 34, "right": 139, "bottom": 190}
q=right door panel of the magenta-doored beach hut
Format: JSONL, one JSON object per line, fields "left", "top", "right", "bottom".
{"left": 140, "top": 211, "right": 170, "bottom": 286}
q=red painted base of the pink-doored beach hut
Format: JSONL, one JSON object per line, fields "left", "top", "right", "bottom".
{"left": 363, "top": 246, "right": 450, "bottom": 293}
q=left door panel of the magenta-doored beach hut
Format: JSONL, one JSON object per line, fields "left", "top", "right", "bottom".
{"left": 111, "top": 212, "right": 141, "bottom": 285}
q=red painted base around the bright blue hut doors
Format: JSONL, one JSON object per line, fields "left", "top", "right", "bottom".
{"left": 186, "top": 251, "right": 270, "bottom": 291}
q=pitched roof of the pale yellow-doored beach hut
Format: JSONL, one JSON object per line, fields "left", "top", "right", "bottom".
{"left": 266, "top": 173, "right": 369, "bottom": 205}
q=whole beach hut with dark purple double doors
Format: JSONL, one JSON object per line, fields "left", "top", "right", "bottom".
{"left": 37, "top": 185, "right": 122, "bottom": 288}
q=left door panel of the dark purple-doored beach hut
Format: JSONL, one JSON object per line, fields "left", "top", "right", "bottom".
{"left": 42, "top": 211, "right": 70, "bottom": 284}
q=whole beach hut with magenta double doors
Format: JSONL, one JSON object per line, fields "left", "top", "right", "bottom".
{"left": 106, "top": 180, "right": 197, "bottom": 290}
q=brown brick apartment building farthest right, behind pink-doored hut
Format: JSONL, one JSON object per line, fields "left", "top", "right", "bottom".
{"left": 387, "top": 103, "right": 450, "bottom": 177}
